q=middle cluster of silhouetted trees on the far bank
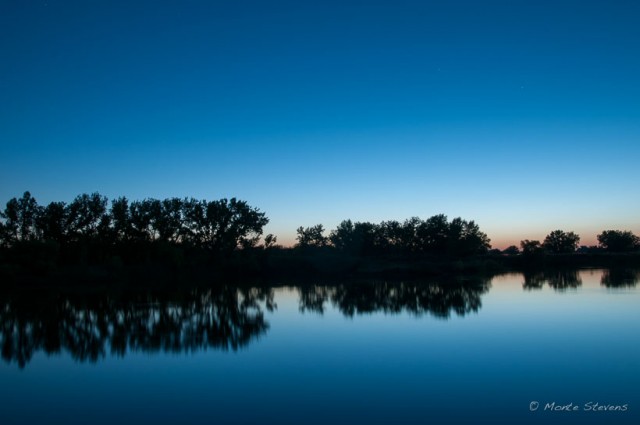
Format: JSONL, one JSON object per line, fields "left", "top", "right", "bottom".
{"left": 296, "top": 214, "right": 491, "bottom": 256}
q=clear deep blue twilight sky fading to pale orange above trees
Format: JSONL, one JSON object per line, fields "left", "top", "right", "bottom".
{"left": 0, "top": 0, "right": 640, "bottom": 248}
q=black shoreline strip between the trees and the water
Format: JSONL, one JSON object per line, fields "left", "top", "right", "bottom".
{"left": 0, "top": 243, "right": 640, "bottom": 290}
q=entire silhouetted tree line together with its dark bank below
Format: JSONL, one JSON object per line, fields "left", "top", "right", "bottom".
{"left": 0, "top": 192, "right": 640, "bottom": 277}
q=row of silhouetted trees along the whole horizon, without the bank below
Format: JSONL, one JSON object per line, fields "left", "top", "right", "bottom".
{"left": 0, "top": 192, "right": 640, "bottom": 268}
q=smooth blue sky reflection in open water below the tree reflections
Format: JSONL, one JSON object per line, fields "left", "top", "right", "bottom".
{"left": 0, "top": 271, "right": 640, "bottom": 423}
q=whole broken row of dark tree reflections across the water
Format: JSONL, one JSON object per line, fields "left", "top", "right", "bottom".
{"left": 0, "top": 269, "right": 640, "bottom": 368}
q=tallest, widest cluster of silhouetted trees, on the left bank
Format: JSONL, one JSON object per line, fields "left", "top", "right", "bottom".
{"left": 0, "top": 192, "right": 268, "bottom": 250}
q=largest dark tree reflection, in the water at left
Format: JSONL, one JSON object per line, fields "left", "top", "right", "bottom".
{"left": 0, "top": 286, "right": 275, "bottom": 368}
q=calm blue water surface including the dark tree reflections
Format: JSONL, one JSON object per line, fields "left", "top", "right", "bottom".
{"left": 0, "top": 270, "right": 640, "bottom": 424}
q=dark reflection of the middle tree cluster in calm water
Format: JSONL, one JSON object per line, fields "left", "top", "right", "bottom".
{"left": 298, "top": 278, "right": 491, "bottom": 319}
